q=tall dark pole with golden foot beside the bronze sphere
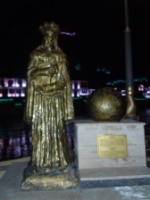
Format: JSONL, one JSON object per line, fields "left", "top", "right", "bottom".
{"left": 124, "top": 0, "right": 136, "bottom": 119}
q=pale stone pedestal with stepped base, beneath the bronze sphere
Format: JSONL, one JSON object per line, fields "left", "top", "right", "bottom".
{"left": 75, "top": 119, "right": 150, "bottom": 187}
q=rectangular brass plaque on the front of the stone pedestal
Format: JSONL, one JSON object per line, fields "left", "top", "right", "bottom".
{"left": 97, "top": 134, "right": 127, "bottom": 158}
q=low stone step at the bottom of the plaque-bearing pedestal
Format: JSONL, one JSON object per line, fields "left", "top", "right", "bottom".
{"left": 79, "top": 167, "right": 150, "bottom": 188}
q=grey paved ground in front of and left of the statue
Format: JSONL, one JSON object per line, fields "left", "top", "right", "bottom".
{"left": 0, "top": 157, "right": 150, "bottom": 200}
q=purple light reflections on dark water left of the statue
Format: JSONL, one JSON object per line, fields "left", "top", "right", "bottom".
{"left": 0, "top": 120, "right": 32, "bottom": 160}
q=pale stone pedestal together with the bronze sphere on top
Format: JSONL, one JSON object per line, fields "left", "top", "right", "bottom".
{"left": 75, "top": 87, "right": 150, "bottom": 188}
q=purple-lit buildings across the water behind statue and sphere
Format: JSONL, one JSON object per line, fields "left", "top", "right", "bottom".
{"left": 0, "top": 78, "right": 150, "bottom": 99}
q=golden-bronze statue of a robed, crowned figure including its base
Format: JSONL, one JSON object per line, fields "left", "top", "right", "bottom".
{"left": 22, "top": 22, "right": 77, "bottom": 190}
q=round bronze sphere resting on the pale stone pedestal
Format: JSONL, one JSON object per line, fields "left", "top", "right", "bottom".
{"left": 87, "top": 87, "right": 125, "bottom": 121}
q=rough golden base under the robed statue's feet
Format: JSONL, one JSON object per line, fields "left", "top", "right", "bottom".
{"left": 21, "top": 167, "right": 78, "bottom": 191}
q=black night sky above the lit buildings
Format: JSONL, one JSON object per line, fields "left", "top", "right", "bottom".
{"left": 0, "top": 0, "right": 150, "bottom": 83}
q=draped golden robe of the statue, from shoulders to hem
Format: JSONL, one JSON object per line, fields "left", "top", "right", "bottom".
{"left": 25, "top": 46, "right": 74, "bottom": 173}
